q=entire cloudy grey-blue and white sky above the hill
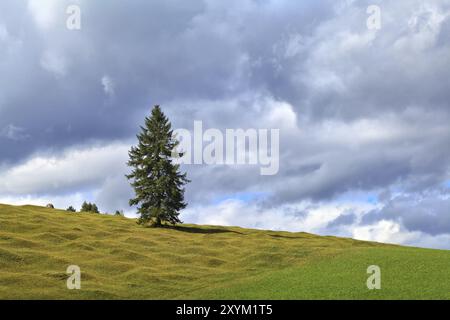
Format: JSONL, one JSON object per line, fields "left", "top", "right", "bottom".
{"left": 0, "top": 0, "right": 450, "bottom": 249}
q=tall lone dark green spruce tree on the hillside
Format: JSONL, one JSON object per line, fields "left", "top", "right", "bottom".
{"left": 127, "top": 106, "right": 189, "bottom": 227}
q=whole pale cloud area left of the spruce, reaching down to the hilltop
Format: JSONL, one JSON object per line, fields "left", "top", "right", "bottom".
{"left": 0, "top": 142, "right": 135, "bottom": 217}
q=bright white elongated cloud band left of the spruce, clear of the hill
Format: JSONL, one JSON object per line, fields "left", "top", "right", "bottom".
{"left": 0, "top": 143, "right": 129, "bottom": 195}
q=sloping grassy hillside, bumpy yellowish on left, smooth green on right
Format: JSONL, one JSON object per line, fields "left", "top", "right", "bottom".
{"left": 0, "top": 205, "right": 450, "bottom": 299}
